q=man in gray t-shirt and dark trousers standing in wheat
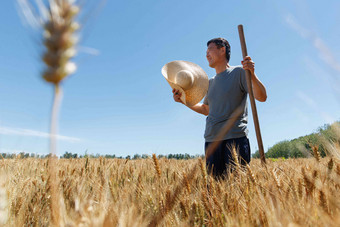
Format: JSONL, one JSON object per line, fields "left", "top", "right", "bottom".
{"left": 172, "top": 38, "right": 267, "bottom": 177}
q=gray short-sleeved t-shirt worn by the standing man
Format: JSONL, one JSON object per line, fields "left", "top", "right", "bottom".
{"left": 203, "top": 66, "right": 248, "bottom": 142}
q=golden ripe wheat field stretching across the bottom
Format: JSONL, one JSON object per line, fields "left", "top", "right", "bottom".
{"left": 0, "top": 153, "right": 340, "bottom": 226}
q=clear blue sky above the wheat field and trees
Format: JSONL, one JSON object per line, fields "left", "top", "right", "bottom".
{"left": 0, "top": 0, "right": 340, "bottom": 156}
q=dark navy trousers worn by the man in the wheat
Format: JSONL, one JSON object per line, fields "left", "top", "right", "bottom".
{"left": 205, "top": 136, "right": 251, "bottom": 178}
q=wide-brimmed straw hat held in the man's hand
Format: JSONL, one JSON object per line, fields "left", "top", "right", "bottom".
{"left": 162, "top": 61, "right": 209, "bottom": 106}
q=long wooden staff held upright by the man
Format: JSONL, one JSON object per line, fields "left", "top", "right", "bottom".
{"left": 238, "top": 24, "right": 266, "bottom": 164}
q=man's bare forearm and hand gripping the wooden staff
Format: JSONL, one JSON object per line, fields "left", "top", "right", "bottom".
{"left": 242, "top": 56, "right": 267, "bottom": 102}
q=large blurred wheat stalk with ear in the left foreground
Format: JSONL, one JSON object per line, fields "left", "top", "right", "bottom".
{"left": 18, "top": 0, "right": 80, "bottom": 226}
